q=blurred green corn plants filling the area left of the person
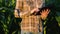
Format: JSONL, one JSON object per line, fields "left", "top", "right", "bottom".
{"left": 0, "top": 0, "right": 19, "bottom": 34}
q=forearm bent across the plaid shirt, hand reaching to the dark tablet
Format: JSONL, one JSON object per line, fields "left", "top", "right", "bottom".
{"left": 14, "top": 8, "right": 39, "bottom": 18}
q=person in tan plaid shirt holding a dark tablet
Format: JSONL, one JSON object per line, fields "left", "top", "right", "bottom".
{"left": 15, "top": 0, "right": 49, "bottom": 34}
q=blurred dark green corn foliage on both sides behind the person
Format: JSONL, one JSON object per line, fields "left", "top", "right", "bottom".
{"left": 0, "top": 0, "right": 60, "bottom": 34}
